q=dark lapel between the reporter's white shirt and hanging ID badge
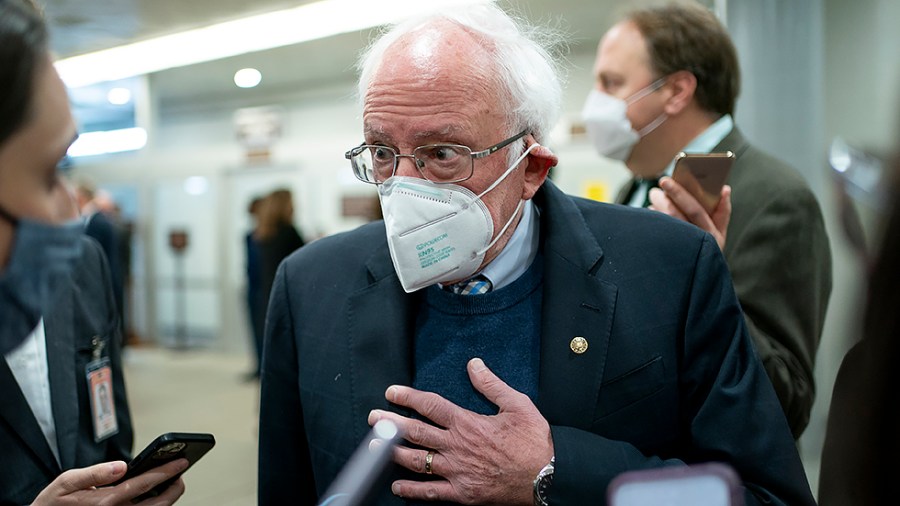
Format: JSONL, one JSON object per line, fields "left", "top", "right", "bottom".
{"left": 44, "top": 276, "right": 80, "bottom": 469}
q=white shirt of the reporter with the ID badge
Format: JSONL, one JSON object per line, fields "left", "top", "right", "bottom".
{"left": 4, "top": 318, "right": 59, "bottom": 463}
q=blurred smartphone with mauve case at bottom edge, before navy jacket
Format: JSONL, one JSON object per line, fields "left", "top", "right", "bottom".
{"left": 607, "top": 462, "right": 744, "bottom": 506}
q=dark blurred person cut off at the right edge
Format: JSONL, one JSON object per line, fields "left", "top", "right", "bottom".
{"left": 818, "top": 149, "right": 900, "bottom": 506}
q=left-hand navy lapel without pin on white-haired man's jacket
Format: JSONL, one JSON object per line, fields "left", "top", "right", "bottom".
{"left": 346, "top": 243, "right": 417, "bottom": 440}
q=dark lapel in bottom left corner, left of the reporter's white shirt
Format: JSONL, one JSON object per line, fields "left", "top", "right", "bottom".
{"left": 0, "top": 340, "right": 60, "bottom": 476}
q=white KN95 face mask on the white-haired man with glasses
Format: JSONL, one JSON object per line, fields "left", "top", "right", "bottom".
{"left": 378, "top": 143, "right": 539, "bottom": 293}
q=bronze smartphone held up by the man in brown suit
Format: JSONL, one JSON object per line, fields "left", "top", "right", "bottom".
{"left": 672, "top": 151, "right": 735, "bottom": 214}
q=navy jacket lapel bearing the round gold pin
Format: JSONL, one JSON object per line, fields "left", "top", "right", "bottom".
{"left": 538, "top": 182, "right": 617, "bottom": 429}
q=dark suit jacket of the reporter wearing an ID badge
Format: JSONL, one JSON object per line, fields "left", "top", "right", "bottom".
{"left": 0, "top": 237, "right": 133, "bottom": 505}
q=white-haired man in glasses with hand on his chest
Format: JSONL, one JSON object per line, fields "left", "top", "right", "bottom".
{"left": 259, "top": 1, "right": 813, "bottom": 504}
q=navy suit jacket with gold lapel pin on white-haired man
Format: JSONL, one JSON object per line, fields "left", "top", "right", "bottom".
{"left": 259, "top": 182, "right": 814, "bottom": 505}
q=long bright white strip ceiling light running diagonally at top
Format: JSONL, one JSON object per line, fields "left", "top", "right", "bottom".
{"left": 56, "top": 0, "right": 487, "bottom": 87}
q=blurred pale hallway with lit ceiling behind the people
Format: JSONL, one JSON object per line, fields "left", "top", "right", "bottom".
{"left": 38, "top": 0, "right": 900, "bottom": 504}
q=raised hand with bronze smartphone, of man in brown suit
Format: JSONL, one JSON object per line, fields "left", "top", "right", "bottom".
{"left": 650, "top": 151, "right": 735, "bottom": 249}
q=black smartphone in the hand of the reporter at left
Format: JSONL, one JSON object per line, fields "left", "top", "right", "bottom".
{"left": 113, "top": 432, "right": 216, "bottom": 502}
